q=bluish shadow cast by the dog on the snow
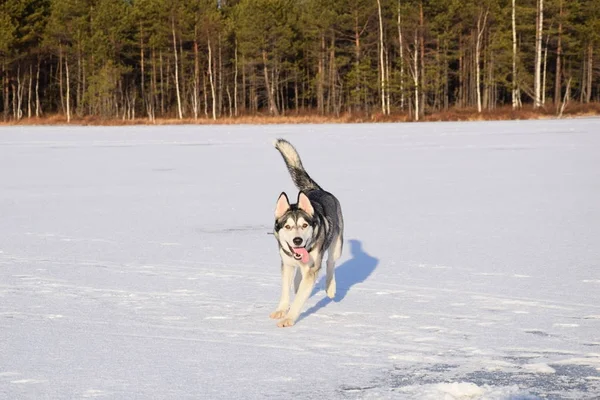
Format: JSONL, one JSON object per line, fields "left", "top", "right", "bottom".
{"left": 298, "top": 239, "right": 379, "bottom": 321}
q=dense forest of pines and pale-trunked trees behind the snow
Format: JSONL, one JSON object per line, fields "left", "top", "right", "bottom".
{"left": 0, "top": 0, "right": 600, "bottom": 122}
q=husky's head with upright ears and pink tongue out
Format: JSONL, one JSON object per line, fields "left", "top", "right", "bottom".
{"left": 275, "top": 192, "right": 315, "bottom": 262}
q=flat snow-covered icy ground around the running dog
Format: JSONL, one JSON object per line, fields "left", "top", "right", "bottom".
{"left": 0, "top": 118, "right": 600, "bottom": 400}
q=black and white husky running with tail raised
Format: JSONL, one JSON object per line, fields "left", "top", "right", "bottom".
{"left": 270, "top": 139, "right": 344, "bottom": 327}
